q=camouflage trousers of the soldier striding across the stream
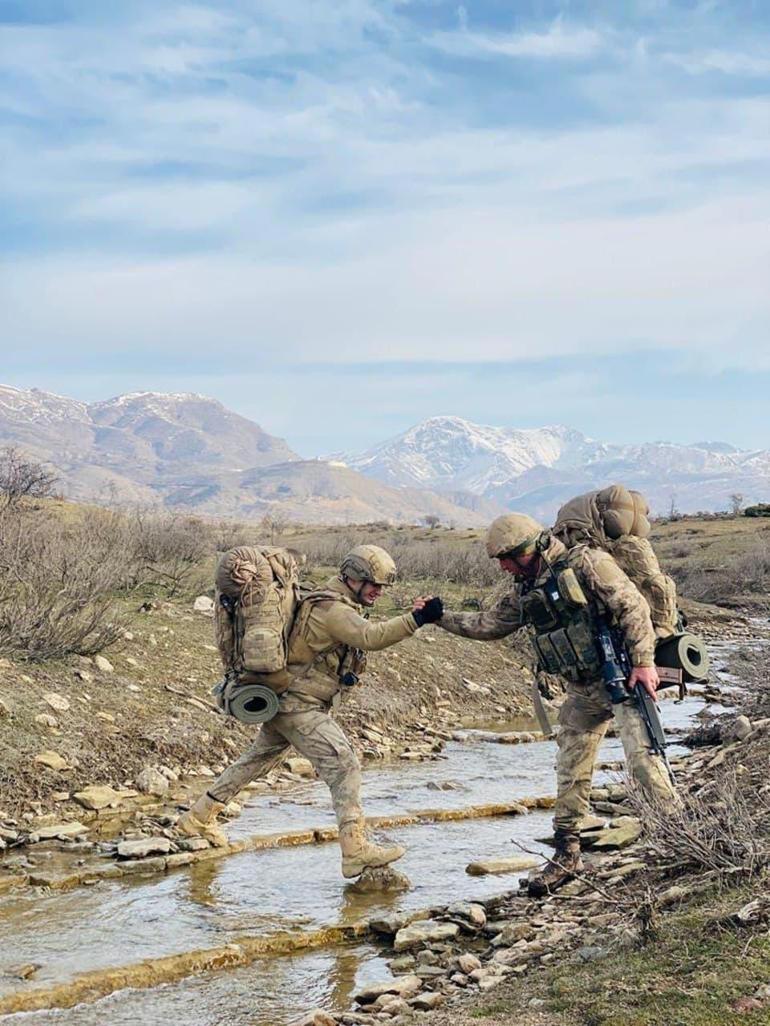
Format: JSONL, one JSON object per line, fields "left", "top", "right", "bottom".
{"left": 207, "top": 708, "right": 363, "bottom": 826}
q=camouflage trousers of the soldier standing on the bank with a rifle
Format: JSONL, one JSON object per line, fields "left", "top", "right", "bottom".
{"left": 553, "top": 681, "right": 677, "bottom": 832}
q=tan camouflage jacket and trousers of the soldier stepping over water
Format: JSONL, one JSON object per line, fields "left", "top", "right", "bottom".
{"left": 208, "top": 578, "right": 417, "bottom": 826}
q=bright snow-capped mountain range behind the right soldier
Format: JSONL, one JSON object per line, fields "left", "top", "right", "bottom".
{"left": 347, "top": 417, "right": 770, "bottom": 519}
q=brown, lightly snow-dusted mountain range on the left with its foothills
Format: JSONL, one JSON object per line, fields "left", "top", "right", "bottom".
{"left": 0, "top": 386, "right": 501, "bottom": 525}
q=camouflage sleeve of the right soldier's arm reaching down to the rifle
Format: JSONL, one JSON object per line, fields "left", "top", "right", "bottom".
{"left": 580, "top": 549, "right": 655, "bottom": 666}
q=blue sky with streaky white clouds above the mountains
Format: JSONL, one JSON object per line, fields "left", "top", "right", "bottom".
{"left": 0, "top": 0, "right": 770, "bottom": 456}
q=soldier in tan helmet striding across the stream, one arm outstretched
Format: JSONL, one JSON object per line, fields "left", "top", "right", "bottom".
{"left": 178, "top": 545, "right": 441, "bottom": 877}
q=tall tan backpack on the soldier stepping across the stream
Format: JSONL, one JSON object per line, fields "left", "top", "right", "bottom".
{"left": 215, "top": 546, "right": 300, "bottom": 693}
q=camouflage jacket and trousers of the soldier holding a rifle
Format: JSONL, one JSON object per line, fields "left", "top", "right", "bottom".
{"left": 438, "top": 538, "right": 673, "bottom": 832}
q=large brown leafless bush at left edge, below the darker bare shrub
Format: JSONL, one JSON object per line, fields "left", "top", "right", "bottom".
{"left": 0, "top": 509, "right": 126, "bottom": 660}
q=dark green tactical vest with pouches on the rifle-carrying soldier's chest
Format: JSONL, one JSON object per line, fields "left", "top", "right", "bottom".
{"left": 519, "top": 561, "right": 603, "bottom": 682}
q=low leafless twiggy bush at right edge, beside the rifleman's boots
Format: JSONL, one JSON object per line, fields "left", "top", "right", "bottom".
{"left": 628, "top": 770, "right": 770, "bottom": 877}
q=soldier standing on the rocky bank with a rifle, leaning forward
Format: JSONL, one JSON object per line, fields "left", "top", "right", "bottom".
{"left": 438, "top": 513, "right": 676, "bottom": 897}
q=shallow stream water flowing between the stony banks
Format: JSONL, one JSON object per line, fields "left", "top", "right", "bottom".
{"left": 0, "top": 685, "right": 739, "bottom": 1026}
